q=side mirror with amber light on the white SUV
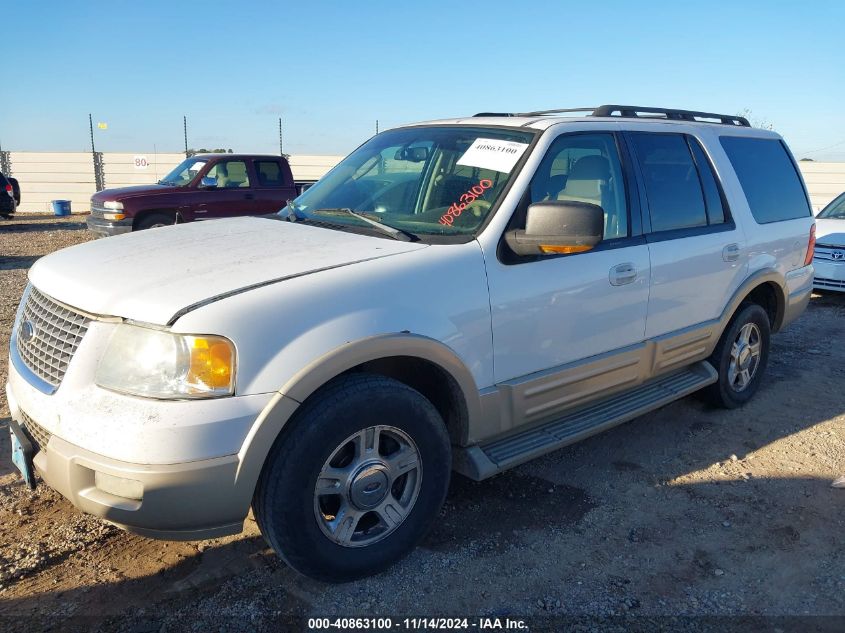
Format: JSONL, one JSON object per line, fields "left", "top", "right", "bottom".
{"left": 505, "top": 200, "right": 604, "bottom": 255}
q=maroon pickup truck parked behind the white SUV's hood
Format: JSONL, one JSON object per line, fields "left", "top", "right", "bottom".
{"left": 87, "top": 154, "right": 310, "bottom": 235}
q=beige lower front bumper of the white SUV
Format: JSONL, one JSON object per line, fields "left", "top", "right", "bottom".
{"left": 6, "top": 385, "right": 252, "bottom": 540}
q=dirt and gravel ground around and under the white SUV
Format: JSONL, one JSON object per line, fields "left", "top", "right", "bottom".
{"left": 0, "top": 216, "right": 845, "bottom": 632}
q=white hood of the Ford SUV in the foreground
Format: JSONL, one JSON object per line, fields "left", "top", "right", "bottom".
{"left": 29, "top": 217, "right": 426, "bottom": 325}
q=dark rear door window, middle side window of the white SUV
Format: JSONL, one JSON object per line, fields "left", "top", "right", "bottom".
{"left": 631, "top": 132, "right": 707, "bottom": 232}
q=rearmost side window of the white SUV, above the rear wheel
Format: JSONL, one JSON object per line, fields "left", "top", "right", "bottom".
{"left": 720, "top": 136, "right": 812, "bottom": 224}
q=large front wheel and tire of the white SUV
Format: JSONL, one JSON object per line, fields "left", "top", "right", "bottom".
{"left": 253, "top": 374, "right": 451, "bottom": 582}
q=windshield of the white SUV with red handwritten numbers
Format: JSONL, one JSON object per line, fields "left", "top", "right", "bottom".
{"left": 281, "top": 126, "right": 534, "bottom": 236}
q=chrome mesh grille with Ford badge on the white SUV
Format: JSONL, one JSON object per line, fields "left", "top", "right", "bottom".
{"left": 16, "top": 286, "right": 91, "bottom": 387}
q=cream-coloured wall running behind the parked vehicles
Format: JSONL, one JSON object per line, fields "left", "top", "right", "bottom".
{"left": 3, "top": 152, "right": 845, "bottom": 212}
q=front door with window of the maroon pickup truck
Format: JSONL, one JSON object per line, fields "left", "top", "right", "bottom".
{"left": 194, "top": 158, "right": 261, "bottom": 220}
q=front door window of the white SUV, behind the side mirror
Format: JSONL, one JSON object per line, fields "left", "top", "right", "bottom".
{"left": 530, "top": 134, "right": 628, "bottom": 240}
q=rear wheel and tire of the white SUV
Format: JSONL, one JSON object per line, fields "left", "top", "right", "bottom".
{"left": 704, "top": 303, "right": 771, "bottom": 409}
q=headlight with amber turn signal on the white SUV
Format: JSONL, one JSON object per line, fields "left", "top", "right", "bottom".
{"left": 96, "top": 324, "right": 235, "bottom": 398}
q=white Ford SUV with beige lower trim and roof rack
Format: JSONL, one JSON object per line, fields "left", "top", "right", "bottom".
{"left": 6, "top": 106, "right": 814, "bottom": 581}
